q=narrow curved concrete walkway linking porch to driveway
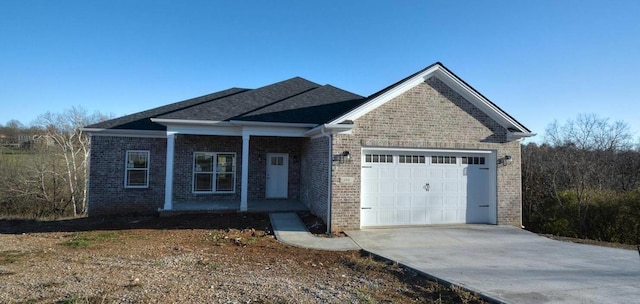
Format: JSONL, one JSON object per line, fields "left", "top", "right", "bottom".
{"left": 269, "top": 212, "right": 360, "bottom": 251}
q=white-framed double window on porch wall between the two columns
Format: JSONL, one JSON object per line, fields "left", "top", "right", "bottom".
{"left": 193, "top": 152, "right": 236, "bottom": 193}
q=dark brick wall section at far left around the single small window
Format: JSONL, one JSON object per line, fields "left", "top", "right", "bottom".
{"left": 87, "top": 136, "right": 167, "bottom": 216}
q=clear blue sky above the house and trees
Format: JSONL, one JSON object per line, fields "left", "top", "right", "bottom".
{"left": 0, "top": 0, "right": 640, "bottom": 139}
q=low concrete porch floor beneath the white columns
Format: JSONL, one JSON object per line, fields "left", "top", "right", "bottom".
{"left": 158, "top": 200, "right": 309, "bottom": 215}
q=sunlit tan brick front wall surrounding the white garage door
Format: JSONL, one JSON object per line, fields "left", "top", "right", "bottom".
{"left": 331, "top": 77, "right": 521, "bottom": 231}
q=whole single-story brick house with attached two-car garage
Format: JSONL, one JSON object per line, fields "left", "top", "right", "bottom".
{"left": 85, "top": 63, "right": 535, "bottom": 231}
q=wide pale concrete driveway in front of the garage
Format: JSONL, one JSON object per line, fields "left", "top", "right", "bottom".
{"left": 347, "top": 225, "right": 640, "bottom": 303}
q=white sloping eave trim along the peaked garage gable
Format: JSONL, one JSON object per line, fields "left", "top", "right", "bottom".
{"left": 329, "top": 64, "right": 535, "bottom": 136}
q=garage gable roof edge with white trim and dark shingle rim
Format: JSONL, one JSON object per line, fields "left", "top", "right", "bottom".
{"left": 328, "top": 62, "right": 535, "bottom": 139}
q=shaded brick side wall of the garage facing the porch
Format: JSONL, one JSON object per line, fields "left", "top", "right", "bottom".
{"left": 300, "top": 137, "right": 329, "bottom": 223}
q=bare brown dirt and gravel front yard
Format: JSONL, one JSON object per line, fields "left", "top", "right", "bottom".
{"left": 0, "top": 214, "right": 484, "bottom": 303}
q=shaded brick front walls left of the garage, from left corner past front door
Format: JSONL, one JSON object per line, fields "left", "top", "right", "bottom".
{"left": 88, "top": 134, "right": 304, "bottom": 216}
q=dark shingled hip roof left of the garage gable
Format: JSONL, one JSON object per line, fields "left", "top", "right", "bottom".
{"left": 87, "top": 77, "right": 366, "bottom": 130}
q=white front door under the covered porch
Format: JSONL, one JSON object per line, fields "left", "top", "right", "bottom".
{"left": 265, "top": 153, "right": 289, "bottom": 198}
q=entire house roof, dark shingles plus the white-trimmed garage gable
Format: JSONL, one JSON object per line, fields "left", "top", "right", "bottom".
{"left": 85, "top": 62, "right": 535, "bottom": 140}
